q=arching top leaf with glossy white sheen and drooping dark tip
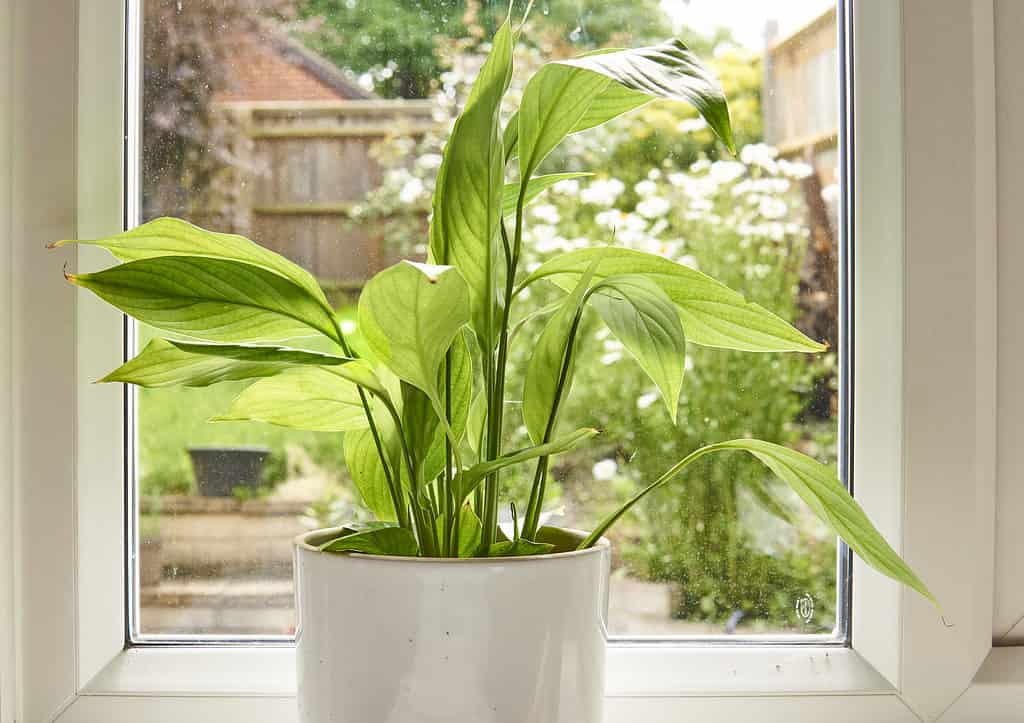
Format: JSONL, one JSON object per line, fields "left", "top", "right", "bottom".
{"left": 520, "top": 40, "right": 735, "bottom": 183}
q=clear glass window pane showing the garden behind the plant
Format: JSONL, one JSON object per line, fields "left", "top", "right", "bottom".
{"left": 135, "top": 0, "right": 842, "bottom": 638}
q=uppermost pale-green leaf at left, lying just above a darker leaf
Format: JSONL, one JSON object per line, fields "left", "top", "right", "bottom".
{"left": 52, "top": 218, "right": 331, "bottom": 310}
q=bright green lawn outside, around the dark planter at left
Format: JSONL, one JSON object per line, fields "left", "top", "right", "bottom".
{"left": 138, "top": 306, "right": 355, "bottom": 495}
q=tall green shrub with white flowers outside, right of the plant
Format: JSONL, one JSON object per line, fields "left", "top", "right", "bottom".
{"left": 491, "top": 144, "right": 836, "bottom": 630}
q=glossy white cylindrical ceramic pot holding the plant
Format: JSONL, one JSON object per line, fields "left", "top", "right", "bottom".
{"left": 295, "top": 529, "right": 609, "bottom": 723}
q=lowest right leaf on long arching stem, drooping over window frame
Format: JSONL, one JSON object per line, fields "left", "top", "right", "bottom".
{"left": 580, "top": 439, "right": 938, "bottom": 605}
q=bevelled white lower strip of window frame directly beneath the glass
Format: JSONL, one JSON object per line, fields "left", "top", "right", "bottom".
{"left": 83, "top": 645, "right": 894, "bottom": 698}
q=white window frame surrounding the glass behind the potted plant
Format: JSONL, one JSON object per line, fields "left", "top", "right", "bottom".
{"left": 0, "top": 0, "right": 1011, "bottom": 723}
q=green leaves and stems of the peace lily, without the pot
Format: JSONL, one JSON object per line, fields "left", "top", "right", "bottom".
{"left": 55, "top": 11, "right": 932, "bottom": 598}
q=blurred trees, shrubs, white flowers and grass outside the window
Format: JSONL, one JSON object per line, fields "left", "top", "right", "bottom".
{"left": 139, "top": 0, "right": 837, "bottom": 632}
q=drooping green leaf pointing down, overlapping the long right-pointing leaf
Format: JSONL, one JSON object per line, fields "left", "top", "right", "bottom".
{"left": 591, "top": 274, "right": 686, "bottom": 424}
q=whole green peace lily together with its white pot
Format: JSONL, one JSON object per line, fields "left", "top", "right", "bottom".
{"left": 59, "top": 11, "right": 931, "bottom": 723}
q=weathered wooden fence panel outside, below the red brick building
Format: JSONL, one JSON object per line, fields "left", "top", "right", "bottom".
{"left": 211, "top": 100, "right": 437, "bottom": 288}
